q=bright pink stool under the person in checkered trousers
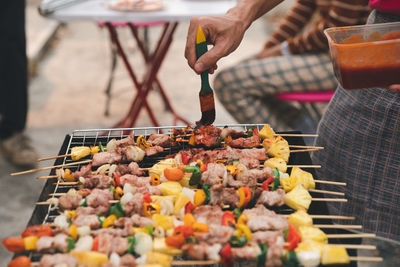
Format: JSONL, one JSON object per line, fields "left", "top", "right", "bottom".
{"left": 276, "top": 90, "right": 335, "bottom": 125}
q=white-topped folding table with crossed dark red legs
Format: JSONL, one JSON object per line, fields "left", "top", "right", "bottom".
{"left": 42, "top": 0, "right": 236, "bottom": 128}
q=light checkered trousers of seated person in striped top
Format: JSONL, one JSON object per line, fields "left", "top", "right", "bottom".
{"left": 214, "top": 53, "right": 337, "bottom": 130}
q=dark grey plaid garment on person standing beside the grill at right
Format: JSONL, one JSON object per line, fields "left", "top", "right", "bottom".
{"left": 312, "top": 9, "right": 400, "bottom": 241}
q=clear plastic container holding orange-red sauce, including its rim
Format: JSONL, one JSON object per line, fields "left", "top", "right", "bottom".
{"left": 324, "top": 22, "right": 400, "bottom": 89}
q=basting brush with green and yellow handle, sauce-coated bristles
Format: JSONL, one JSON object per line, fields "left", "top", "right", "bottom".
{"left": 196, "top": 27, "right": 215, "bottom": 128}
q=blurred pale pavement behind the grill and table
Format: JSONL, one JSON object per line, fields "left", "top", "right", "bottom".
{"left": 0, "top": 0, "right": 294, "bottom": 266}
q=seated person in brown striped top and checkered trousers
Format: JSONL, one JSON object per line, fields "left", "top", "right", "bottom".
{"left": 214, "top": 0, "right": 370, "bottom": 131}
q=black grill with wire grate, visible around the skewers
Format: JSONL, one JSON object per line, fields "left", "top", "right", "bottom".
{"left": 28, "top": 124, "right": 361, "bottom": 266}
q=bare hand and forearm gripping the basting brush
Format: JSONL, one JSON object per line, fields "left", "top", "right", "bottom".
{"left": 185, "top": 0, "right": 283, "bottom": 73}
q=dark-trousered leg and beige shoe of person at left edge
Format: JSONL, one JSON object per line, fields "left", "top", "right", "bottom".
{"left": 0, "top": 0, "right": 38, "bottom": 166}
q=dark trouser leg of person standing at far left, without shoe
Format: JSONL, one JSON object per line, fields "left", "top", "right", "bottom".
{"left": 0, "top": 0, "right": 27, "bottom": 139}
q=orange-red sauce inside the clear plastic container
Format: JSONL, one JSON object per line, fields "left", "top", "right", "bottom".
{"left": 334, "top": 31, "right": 400, "bottom": 89}
